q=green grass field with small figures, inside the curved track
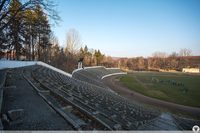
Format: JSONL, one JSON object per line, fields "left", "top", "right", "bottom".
{"left": 120, "top": 72, "right": 200, "bottom": 107}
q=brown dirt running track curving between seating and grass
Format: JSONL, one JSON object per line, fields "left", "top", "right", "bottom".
{"left": 103, "top": 75, "right": 200, "bottom": 118}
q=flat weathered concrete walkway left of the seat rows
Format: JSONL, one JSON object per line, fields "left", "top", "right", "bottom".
{"left": 2, "top": 68, "right": 73, "bottom": 130}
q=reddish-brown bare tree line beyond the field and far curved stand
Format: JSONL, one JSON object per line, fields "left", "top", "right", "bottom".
{"left": 80, "top": 46, "right": 200, "bottom": 71}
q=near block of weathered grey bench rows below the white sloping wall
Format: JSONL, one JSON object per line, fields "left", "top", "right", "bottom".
{"left": 24, "top": 65, "right": 159, "bottom": 130}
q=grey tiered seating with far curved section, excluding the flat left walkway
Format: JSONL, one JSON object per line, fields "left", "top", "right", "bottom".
{"left": 1, "top": 63, "right": 199, "bottom": 130}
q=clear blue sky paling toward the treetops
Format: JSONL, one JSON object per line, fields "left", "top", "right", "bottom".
{"left": 53, "top": 0, "right": 200, "bottom": 57}
